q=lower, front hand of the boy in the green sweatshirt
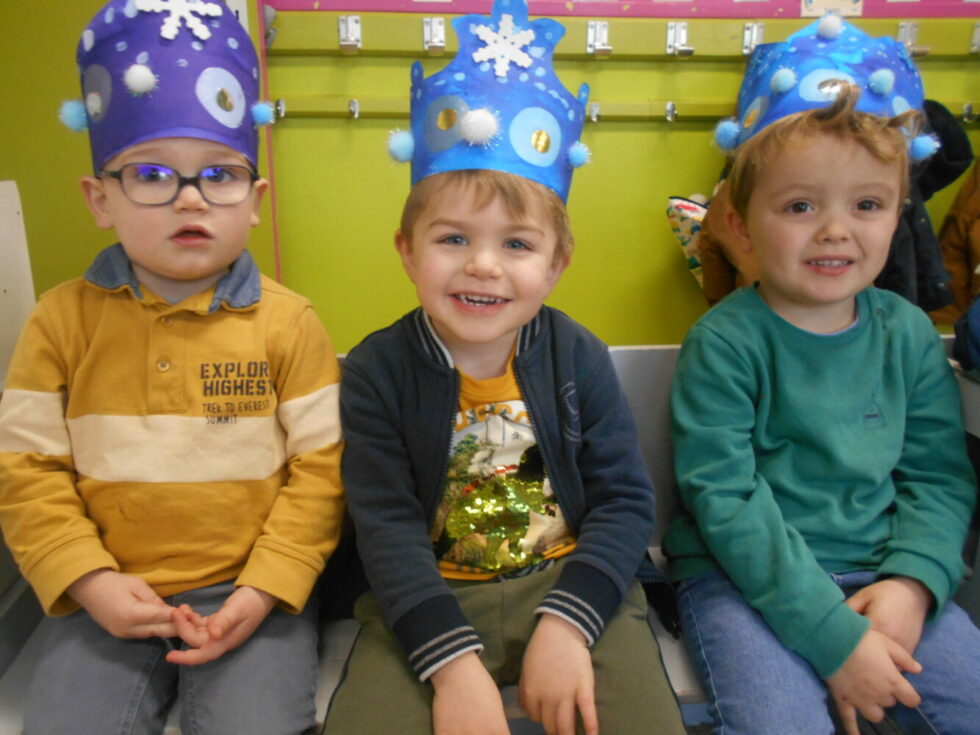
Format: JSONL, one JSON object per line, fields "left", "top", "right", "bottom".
{"left": 826, "top": 629, "right": 922, "bottom": 735}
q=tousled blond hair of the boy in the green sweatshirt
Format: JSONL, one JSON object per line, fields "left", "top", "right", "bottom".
{"left": 728, "top": 82, "right": 920, "bottom": 218}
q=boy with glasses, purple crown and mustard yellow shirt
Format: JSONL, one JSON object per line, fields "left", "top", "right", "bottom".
{"left": 0, "top": 0, "right": 343, "bottom": 735}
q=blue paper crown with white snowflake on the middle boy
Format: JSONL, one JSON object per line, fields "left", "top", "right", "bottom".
{"left": 388, "top": 0, "right": 589, "bottom": 200}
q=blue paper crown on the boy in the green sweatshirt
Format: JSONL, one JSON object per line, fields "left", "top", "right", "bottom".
{"left": 715, "top": 15, "right": 938, "bottom": 160}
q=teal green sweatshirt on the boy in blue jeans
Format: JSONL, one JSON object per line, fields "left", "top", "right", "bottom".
{"left": 664, "top": 287, "right": 976, "bottom": 677}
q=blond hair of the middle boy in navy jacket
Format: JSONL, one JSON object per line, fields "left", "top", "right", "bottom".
{"left": 401, "top": 169, "right": 575, "bottom": 262}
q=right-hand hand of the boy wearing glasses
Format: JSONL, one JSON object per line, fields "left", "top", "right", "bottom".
{"left": 167, "top": 586, "right": 276, "bottom": 666}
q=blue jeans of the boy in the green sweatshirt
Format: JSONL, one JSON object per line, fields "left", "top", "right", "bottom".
{"left": 677, "top": 572, "right": 980, "bottom": 735}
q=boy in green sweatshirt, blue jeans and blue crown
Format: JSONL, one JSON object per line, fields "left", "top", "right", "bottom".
{"left": 664, "top": 16, "right": 980, "bottom": 735}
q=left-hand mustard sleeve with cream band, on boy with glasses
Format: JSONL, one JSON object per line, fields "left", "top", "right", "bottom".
{"left": 0, "top": 298, "right": 119, "bottom": 615}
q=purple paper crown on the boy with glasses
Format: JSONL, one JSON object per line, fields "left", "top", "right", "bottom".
{"left": 61, "top": 0, "right": 272, "bottom": 170}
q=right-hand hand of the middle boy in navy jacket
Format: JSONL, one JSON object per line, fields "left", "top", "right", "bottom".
{"left": 520, "top": 613, "right": 599, "bottom": 735}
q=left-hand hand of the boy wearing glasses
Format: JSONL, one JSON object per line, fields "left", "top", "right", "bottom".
{"left": 67, "top": 569, "right": 177, "bottom": 638}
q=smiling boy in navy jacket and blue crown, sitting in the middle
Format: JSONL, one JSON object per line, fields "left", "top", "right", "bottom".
{"left": 327, "top": 0, "right": 684, "bottom": 735}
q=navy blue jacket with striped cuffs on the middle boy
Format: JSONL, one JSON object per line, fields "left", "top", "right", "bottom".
{"left": 340, "top": 307, "right": 654, "bottom": 679}
